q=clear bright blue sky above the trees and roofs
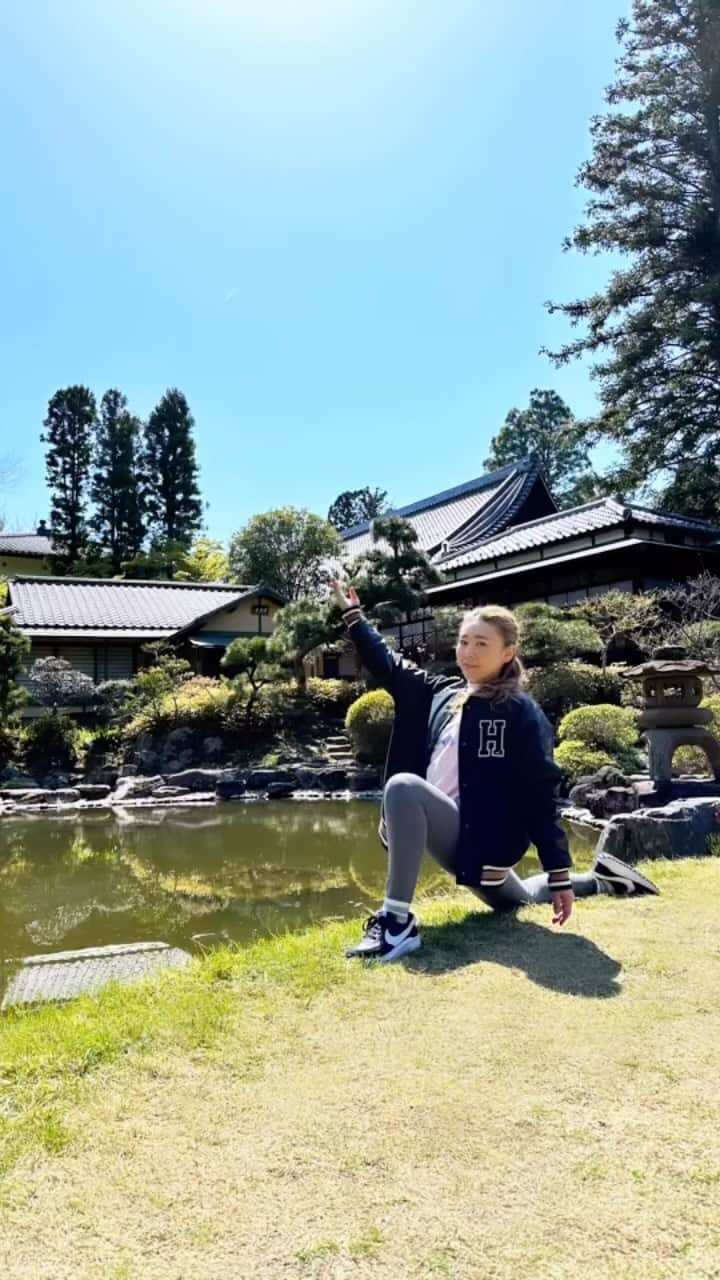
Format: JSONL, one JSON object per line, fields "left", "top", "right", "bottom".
{"left": 0, "top": 0, "right": 628, "bottom": 539}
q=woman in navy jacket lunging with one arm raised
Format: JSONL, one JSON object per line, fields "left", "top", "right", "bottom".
{"left": 332, "top": 579, "right": 659, "bottom": 960}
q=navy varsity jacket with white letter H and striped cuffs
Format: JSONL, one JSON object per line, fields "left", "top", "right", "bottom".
{"left": 346, "top": 609, "right": 573, "bottom": 886}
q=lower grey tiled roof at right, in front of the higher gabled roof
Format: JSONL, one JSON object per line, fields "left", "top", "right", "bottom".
{"left": 436, "top": 498, "right": 715, "bottom": 572}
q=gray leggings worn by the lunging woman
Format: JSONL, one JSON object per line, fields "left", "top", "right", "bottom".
{"left": 384, "top": 773, "right": 601, "bottom": 911}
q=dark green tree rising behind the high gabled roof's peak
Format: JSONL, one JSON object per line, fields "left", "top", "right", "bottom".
{"left": 484, "top": 388, "right": 597, "bottom": 507}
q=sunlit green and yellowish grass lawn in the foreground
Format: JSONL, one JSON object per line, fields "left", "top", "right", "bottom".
{"left": 0, "top": 859, "right": 720, "bottom": 1280}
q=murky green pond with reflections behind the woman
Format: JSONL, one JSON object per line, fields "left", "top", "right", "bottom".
{"left": 0, "top": 800, "right": 592, "bottom": 961}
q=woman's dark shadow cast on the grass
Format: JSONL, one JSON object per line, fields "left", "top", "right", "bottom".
{"left": 400, "top": 911, "right": 621, "bottom": 1000}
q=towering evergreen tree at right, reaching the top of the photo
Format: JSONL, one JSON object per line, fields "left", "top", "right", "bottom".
{"left": 550, "top": 0, "right": 720, "bottom": 488}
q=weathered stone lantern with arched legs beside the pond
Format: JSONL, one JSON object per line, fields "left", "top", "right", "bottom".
{"left": 626, "top": 645, "right": 720, "bottom": 783}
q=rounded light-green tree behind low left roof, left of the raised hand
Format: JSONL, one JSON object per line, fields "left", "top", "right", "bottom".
{"left": 229, "top": 507, "right": 342, "bottom": 600}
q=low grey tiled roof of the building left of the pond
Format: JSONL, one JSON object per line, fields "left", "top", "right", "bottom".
{"left": 9, "top": 576, "right": 255, "bottom": 635}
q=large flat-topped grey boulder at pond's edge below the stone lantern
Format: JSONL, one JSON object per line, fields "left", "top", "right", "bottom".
{"left": 598, "top": 797, "right": 720, "bottom": 863}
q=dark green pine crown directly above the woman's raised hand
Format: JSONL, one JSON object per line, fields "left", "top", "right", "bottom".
{"left": 354, "top": 516, "right": 441, "bottom": 625}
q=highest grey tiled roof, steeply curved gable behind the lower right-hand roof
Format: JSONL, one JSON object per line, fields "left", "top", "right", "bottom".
{"left": 342, "top": 460, "right": 539, "bottom": 559}
